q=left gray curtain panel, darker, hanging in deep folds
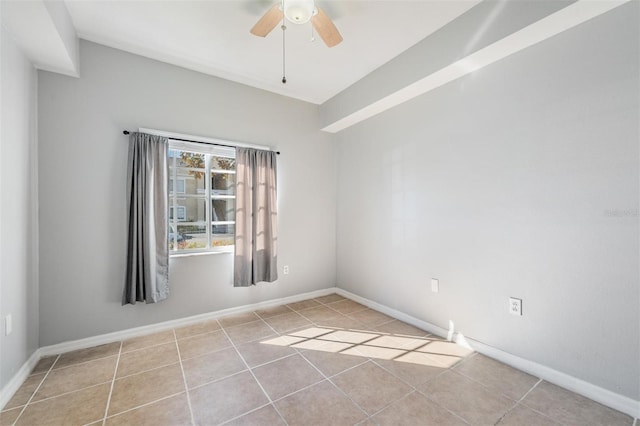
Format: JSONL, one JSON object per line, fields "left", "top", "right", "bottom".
{"left": 122, "top": 133, "right": 169, "bottom": 305}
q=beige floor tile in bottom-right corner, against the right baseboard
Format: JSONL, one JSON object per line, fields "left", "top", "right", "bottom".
{"left": 522, "top": 382, "right": 633, "bottom": 426}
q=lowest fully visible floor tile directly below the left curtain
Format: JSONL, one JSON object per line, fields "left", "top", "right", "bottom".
{"left": 108, "top": 364, "right": 185, "bottom": 416}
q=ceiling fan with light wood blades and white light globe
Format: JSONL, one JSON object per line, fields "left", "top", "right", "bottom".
{"left": 251, "top": 0, "right": 342, "bottom": 47}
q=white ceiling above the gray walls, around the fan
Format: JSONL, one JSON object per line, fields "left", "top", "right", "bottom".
{"left": 65, "top": 0, "right": 479, "bottom": 104}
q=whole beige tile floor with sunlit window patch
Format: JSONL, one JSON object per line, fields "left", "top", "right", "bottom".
{"left": 0, "top": 294, "right": 634, "bottom": 426}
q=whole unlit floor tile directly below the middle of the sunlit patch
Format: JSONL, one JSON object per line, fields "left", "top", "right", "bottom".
{"left": 332, "top": 362, "right": 412, "bottom": 414}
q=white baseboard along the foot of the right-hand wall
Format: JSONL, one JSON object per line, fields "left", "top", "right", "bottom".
{"left": 336, "top": 288, "right": 640, "bottom": 423}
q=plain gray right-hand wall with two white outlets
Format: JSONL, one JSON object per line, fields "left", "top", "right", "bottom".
{"left": 336, "top": 2, "right": 640, "bottom": 400}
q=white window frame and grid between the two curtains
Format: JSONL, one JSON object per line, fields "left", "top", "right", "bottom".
{"left": 169, "top": 139, "right": 236, "bottom": 256}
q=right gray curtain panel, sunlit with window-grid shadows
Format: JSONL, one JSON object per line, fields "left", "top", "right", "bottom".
{"left": 233, "top": 148, "right": 278, "bottom": 287}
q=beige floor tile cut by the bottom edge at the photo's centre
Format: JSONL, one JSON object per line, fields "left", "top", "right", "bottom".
{"left": 275, "top": 380, "right": 367, "bottom": 426}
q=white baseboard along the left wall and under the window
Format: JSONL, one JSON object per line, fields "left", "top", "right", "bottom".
{"left": 0, "top": 287, "right": 337, "bottom": 410}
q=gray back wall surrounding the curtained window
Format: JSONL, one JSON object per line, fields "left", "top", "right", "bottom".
{"left": 38, "top": 41, "right": 336, "bottom": 346}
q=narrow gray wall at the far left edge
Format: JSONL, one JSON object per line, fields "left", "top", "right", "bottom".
{"left": 0, "top": 26, "right": 38, "bottom": 389}
